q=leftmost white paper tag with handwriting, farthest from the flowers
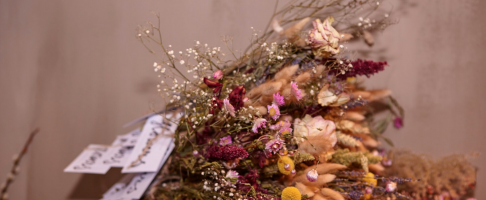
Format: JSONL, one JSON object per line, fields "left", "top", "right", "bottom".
{"left": 64, "top": 144, "right": 110, "bottom": 174}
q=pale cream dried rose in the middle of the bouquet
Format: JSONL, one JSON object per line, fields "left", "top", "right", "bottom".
{"left": 294, "top": 115, "right": 337, "bottom": 146}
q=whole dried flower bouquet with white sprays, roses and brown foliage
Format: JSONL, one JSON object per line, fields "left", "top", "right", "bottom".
{"left": 131, "top": 0, "right": 475, "bottom": 200}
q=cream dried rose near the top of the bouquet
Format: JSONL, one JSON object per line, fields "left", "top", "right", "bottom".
{"left": 308, "top": 17, "right": 341, "bottom": 56}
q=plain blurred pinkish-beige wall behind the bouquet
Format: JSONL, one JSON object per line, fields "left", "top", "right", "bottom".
{"left": 0, "top": 0, "right": 486, "bottom": 200}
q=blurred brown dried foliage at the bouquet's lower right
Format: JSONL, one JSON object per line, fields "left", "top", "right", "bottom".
{"left": 384, "top": 150, "right": 476, "bottom": 198}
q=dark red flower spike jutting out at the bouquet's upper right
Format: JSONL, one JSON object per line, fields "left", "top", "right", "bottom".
{"left": 336, "top": 59, "right": 388, "bottom": 80}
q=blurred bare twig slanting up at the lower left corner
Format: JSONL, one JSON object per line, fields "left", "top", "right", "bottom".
{"left": 0, "top": 128, "right": 39, "bottom": 200}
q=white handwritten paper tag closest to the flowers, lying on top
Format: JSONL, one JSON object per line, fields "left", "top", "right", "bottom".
{"left": 122, "top": 112, "right": 182, "bottom": 173}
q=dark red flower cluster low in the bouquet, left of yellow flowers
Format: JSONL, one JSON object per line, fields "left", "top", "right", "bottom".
{"left": 204, "top": 145, "right": 248, "bottom": 161}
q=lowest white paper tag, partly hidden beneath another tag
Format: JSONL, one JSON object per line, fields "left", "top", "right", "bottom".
{"left": 102, "top": 140, "right": 175, "bottom": 200}
